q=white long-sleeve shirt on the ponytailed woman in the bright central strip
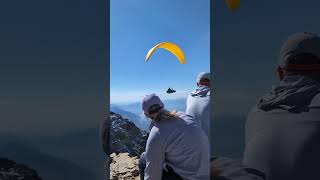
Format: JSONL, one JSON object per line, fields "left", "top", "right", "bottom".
{"left": 144, "top": 113, "right": 210, "bottom": 180}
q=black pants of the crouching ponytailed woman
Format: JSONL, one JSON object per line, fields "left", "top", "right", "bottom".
{"left": 139, "top": 153, "right": 182, "bottom": 180}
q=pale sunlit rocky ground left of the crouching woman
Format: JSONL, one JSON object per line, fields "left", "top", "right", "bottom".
{"left": 110, "top": 153, "right": 140, "bottom": 180}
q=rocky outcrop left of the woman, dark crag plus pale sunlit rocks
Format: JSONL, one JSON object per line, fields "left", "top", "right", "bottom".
{"left": 109, "top": 112, "right": 148, "bottom": 180}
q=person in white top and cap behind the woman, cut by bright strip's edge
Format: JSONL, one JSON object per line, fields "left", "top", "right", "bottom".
{"left": 186, "top": 72, "right": 210, "bottom": 139}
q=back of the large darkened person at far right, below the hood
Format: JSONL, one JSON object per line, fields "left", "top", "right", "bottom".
{"left": 244, "top": 91, "right": 320, "bottom": 180}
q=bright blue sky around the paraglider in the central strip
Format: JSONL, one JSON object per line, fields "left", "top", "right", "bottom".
{"left": 110, "top": 0, "right": 210, "bottom": 103}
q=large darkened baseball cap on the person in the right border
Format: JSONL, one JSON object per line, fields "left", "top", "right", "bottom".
{"left": 279, "top": 32, "right": 320, "bottom": 69}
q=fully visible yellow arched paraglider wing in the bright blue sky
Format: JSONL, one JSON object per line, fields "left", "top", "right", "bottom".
{"left": 146, "top": 42, "right": 186, "bottom": 64}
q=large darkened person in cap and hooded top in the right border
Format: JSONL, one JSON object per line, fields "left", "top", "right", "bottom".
{"left": 243, "top": 33, "right": 320, "bottom": 180}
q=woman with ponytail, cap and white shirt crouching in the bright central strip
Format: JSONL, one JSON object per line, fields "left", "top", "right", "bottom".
{"left": 139, "top": 94, "right": 210, "bottom": 180}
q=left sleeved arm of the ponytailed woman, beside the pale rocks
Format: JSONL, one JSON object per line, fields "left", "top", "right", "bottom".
{"left": 144, "top": 130, "right": 165, "bottom": 180}
